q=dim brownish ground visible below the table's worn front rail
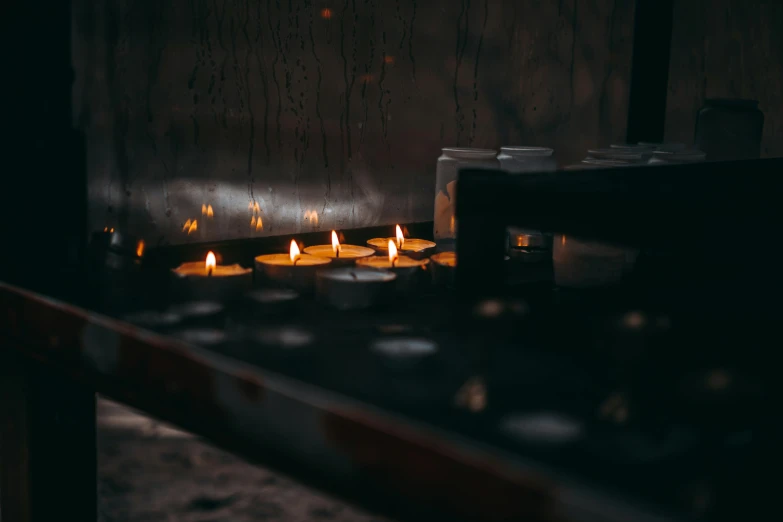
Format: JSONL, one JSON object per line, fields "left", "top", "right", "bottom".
{"left": 98, "top": 399, "right": 382, "bottom": 522}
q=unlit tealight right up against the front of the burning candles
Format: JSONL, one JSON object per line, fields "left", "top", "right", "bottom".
{"left": 316, "top": 266, "right": 397, "bottom": 310}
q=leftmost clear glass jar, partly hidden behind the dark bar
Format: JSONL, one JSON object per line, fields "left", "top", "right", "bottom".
{"left": 433, "top": 147, "right": 500, "bottom": 252}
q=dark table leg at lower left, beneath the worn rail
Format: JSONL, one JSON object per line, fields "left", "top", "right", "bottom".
{"left": 0, "top": 350, "right": 97, "bottom": 522}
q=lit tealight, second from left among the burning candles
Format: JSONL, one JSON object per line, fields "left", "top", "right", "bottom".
{"left": 256, "top": 240, "right": 332, "bottom": 293}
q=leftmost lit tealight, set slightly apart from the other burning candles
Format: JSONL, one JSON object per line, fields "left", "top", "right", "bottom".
{"left": 172, "top": 251, "right": 253, "bottom": 301}
